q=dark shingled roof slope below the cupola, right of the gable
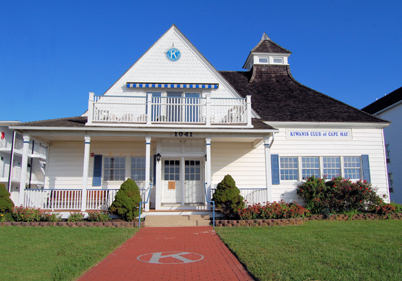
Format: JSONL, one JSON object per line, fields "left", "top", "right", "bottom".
{"left": 220, "top": 65, "right": 388, "bottom": 123}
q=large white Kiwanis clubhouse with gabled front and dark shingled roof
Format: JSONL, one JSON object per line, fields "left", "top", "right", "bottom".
{"left": 10, "top": 25, "right": 388, "bottom": 214}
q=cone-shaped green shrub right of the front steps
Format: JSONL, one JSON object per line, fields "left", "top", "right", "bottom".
{"left": 212, "top": 175, "right": 245, "bottom": 218}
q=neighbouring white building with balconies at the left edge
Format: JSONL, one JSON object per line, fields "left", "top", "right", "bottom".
{"left": 0, "top": 121, "right": 47, "bottom": 202}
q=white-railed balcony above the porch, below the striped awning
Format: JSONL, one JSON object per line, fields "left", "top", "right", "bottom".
{"left": 87, "top": 93, "right": 252, "bottom": 127}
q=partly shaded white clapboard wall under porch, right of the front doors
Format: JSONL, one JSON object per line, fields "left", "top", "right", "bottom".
{"left": 211, "top": 143, "right": 266, "bottom": 188}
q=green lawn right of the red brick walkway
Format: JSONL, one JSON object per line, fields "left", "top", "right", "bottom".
{"left": 216, "top": 220, "right": 402, "bottom": 281}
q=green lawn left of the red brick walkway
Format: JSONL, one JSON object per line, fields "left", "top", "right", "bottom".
{"left": 0, "top": 227, "right": 138, "bottom": 281}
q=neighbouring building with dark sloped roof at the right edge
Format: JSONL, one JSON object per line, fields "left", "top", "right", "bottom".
{"left": 362, "top": 87, "right": 402, "bottom": 204}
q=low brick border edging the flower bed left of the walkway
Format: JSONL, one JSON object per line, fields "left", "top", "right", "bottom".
{"left": 0, "top": 221, "right": 144, "bottom": 228}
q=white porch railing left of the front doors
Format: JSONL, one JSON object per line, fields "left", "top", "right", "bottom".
{"left": 24, "top": 189, "right": 145, "bottom": 211}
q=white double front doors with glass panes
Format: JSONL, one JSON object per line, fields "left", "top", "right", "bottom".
{"left": 161, "top": 157, "right": 204, "bottom": 206}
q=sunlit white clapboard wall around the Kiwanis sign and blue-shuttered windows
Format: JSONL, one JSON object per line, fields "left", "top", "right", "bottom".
{"left": 271, "top": 128, "right": 388, "bottom": 202}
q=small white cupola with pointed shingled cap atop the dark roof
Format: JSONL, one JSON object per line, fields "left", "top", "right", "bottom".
{"left": 243, "top": 32, "right": 292, "bottom": 70}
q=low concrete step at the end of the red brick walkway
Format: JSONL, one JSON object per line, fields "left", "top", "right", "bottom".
{"left": 145, "top": 215, "right": 210, "bottom": 227}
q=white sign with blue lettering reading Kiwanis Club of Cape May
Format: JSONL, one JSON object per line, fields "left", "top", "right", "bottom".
{"left": 286, "top": 129, "right": 352, "bottom": 140}
